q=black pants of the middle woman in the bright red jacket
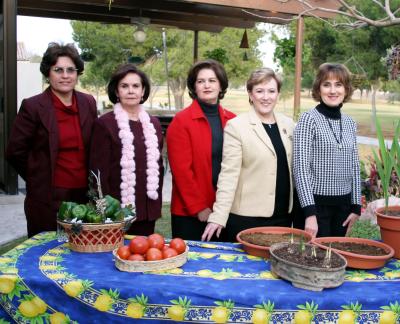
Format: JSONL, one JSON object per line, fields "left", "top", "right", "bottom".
{"left": 171, "top": 215, "right": 223, "bottom": 242}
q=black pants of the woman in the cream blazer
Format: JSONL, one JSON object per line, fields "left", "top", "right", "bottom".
{"left": 223, "top": 213, "right": 292, "bottom": 242}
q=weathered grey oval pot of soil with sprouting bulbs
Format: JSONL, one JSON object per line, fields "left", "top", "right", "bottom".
{"left": 269, "top": 243, "right": 347, "bottom": 291}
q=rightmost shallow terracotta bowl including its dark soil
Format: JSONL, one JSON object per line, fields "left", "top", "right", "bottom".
{"left": 312, "top": 237, "right": 394, "bottom": 269}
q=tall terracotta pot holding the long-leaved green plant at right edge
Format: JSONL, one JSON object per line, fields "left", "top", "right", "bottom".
{"left": 375, "top": 206, "right": 400, "bottom": 259}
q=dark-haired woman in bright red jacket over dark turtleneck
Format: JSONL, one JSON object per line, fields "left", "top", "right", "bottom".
{"left": 167, "top": 60, "right": 235, "bottom": 240}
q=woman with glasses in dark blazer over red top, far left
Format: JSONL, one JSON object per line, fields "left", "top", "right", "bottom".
{"left": 6, "top": 43, "right": 97, "bottom": 237}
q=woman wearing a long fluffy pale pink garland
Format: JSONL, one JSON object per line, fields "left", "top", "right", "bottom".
{"left": 89, "top": 64, "right": 164, "bottom": 235}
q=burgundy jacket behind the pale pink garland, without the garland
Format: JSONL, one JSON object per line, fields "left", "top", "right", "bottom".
{"left": 89, "top": 111, "right": 164, "bottom": 221}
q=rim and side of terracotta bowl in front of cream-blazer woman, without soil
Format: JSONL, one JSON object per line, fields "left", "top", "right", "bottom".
{"left": 236, "top": 226, "right": 312, "bottom": 259}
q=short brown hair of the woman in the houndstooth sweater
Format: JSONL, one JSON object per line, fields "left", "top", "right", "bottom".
{"left": 312, "top": 63, "right": 354, "bottom": 102}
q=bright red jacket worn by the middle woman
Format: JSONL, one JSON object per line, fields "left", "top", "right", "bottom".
{"left": 167, "top": 100, "right": 235, "bottom": 216}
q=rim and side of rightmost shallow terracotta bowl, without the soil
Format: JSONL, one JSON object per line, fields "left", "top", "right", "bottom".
{"left": 312, "top": 237, "right": 394, "bottom": 269}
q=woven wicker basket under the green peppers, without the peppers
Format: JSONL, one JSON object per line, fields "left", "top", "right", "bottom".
{"left": 58, "top": 221, "right": 125, "bottom": 252}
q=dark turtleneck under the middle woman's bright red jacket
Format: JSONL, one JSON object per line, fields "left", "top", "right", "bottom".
{"left": 197, "top": 99, "right": 224, "bottom": 188}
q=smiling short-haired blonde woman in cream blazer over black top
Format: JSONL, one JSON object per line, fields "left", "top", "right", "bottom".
{"left": 202, "top": 68, "right": 294, "bottom": 241}
